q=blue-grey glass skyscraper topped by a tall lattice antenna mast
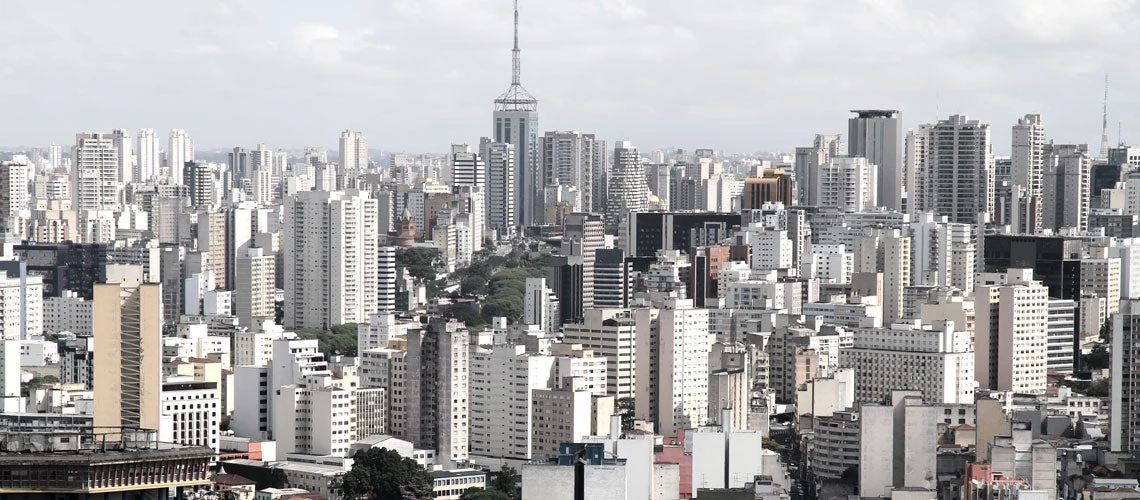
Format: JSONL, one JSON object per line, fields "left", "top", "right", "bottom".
{"left": 492, "top": 0, "right": 543, "bottom": 226}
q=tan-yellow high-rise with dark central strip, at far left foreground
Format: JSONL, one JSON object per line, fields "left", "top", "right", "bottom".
{"left": 92, "top": 267, "right": 162, "bottom": 431}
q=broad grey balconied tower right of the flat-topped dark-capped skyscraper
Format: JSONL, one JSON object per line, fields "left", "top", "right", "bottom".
{"left": 911, "top": 115, "right": 994, "bottom": 224}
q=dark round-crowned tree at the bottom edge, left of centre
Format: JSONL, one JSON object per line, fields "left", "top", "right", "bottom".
{"left": 341, "top": 448, "right": 434, "bottom": 500}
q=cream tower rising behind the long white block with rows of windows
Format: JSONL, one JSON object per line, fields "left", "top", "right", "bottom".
{"left": 855, "top": 228, "right": 912, "bottom": 325}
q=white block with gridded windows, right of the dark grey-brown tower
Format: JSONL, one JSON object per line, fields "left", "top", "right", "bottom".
{"left": 471, "top": 345, "right": 554, "bottom": 460}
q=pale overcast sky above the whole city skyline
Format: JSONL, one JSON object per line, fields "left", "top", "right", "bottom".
{"left": 0, "top": 0, "right": 1140, "bottom": 157}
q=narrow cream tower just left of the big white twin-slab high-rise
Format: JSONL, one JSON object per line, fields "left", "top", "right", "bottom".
{"left": 234, "top": 246, "right": 277, "bottom": 328}
